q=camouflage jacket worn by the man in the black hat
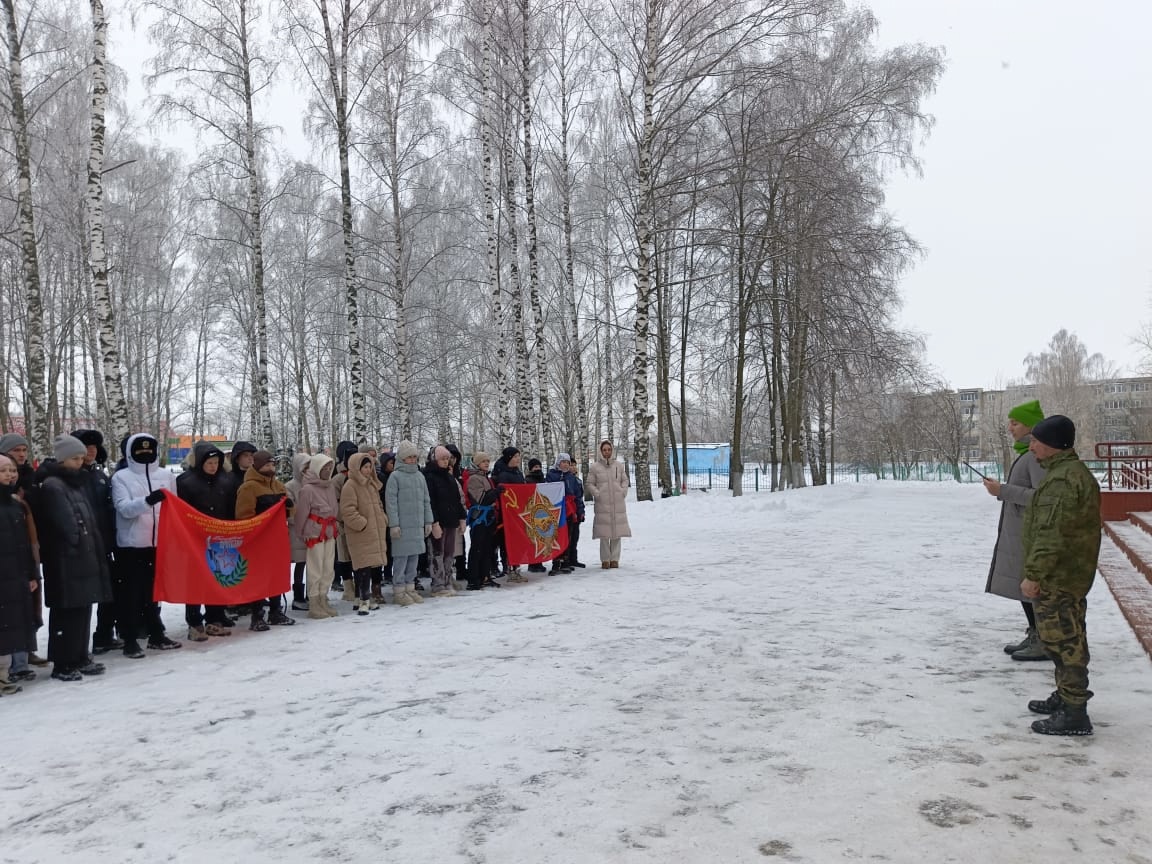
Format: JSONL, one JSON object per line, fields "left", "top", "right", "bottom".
{"left": 1024, "top": 450, "right": 1100, "bottom": 597}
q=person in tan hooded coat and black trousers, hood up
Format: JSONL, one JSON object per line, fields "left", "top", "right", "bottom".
{"left": 340, "top": 453, "right": 388, "bottom": 615}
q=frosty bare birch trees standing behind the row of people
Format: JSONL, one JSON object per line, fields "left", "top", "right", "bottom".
{"left": 0, "top": 0, "right": 943, "bottom": 500}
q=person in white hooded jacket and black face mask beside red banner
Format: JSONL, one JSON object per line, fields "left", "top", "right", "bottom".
{"left": 112, "top": 433, "right": 180, "bottom": 659}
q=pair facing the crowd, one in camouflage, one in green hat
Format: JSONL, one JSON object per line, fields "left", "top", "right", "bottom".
{"left": 984, "top": 400, "right": 1101, "bottom": 735}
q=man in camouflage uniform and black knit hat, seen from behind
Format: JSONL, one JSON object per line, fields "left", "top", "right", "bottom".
{"left": 1021, "top": 414, "right": 1100, "bottom": 735}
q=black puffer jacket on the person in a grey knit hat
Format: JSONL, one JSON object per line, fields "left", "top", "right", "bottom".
{"left": 32, "top": 463, "right": 112, "bottom": 609}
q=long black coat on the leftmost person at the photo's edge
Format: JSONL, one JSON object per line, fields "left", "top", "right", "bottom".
{"left": 0, "top": 486, "right": 39, "bottom": 654}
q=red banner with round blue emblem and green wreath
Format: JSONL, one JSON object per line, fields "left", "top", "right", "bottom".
{"left": 152, "top": 494, "right": 291, "bottom": 606}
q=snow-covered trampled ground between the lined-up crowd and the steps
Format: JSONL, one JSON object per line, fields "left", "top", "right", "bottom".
{"left": 0, "top": 484, "right": 1152, "bottom": 864}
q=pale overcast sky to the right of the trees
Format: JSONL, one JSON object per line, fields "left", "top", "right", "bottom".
{"left": 112, "top": 0, "right": 1152, "bottom": 387}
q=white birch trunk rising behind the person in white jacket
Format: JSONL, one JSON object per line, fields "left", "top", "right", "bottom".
{"left": 86, "top": 0, "right": 128, "bottom": 441}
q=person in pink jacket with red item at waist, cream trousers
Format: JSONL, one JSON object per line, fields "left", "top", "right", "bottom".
{"left": 293, "top": 453, "right": 340, "bottom": 619}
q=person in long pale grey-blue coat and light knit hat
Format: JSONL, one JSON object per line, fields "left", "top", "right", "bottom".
{"left": 384, "top": 440, "right": 432, "bottom": 606}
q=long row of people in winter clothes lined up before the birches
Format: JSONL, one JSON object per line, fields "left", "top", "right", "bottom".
{"left": 0, "top": 430, "right": 631, "bottom": 696}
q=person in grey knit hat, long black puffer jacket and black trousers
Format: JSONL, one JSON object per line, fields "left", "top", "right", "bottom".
{"left": 35, "top": 435, "right": 112, "bottom": 681}
